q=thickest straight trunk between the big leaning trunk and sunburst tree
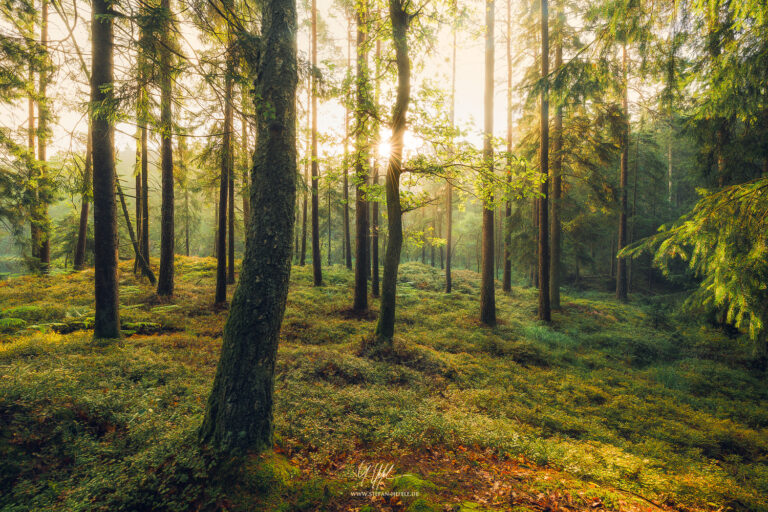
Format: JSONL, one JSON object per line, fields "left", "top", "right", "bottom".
{"left": 352, "top": 5, "right": 370, "bottom": 313}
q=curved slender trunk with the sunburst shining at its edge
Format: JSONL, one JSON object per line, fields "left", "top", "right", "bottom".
{"left": 375, "top": 0, "right": 411, "bottom": 345}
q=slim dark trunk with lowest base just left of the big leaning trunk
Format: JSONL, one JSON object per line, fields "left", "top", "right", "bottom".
{"left": 214, "top": 48, "right": 234, "bottom": 304}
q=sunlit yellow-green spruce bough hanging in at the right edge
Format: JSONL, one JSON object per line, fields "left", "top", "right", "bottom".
{"left": 626, "top": 178, "right": 768, "bottom": 353}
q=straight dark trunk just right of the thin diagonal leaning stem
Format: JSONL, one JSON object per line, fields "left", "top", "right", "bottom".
{"left": 157, "top": 0, "right": 176, "bottom": 296}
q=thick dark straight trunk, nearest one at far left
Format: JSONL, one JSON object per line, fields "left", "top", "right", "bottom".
{"left": 91, "top": 0, "right": 120, "bottom": 339}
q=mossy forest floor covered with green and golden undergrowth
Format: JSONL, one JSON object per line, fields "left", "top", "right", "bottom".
{"left": 0, "top": 258, "right": 768, "bottom": 512}
